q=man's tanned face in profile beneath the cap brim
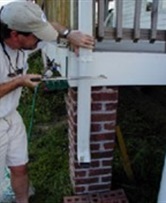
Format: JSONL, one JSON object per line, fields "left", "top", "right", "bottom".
{"left": 18, "top": 34, "right": 41, "bottom": 50}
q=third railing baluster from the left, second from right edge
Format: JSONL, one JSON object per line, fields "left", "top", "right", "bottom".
{"left": 133, "top": 0, "right": 142, "bottom": 42}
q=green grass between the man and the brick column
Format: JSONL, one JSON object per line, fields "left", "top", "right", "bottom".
{"left": 19, "top": 53, "right": 72, "bottom": 203}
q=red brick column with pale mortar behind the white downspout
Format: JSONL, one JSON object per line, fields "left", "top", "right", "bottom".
{"left": 66, "top": 86, "right": 118, "bottom": 194}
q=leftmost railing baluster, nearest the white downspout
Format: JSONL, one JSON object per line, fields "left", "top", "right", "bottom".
{"left": 98, "top": 0, "right": 105, "bottom": 38}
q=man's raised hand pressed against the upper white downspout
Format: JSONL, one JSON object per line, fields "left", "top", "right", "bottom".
{"left": 67, "top": 30, "right": 95, "bottom": 55}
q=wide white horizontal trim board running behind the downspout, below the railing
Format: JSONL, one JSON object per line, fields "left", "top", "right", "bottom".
{"left": 68, "top": 52, "right": 166, "bottom": 86}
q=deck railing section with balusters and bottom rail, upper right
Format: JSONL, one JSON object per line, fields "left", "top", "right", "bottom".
{"left": 94, "top": 0, "right": 166, "bottom": 43}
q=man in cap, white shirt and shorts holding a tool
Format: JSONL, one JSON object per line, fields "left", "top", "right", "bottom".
{"left": 0, "top": 2, "right": 94, "bottom": 203}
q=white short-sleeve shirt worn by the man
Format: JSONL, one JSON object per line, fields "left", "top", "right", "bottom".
{"left": 0, "top": 44, "right": 28, "bottom": 118}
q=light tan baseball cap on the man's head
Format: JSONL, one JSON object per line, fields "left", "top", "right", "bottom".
{"left": 1, "top": 1, "right": 58, "bottom": 41}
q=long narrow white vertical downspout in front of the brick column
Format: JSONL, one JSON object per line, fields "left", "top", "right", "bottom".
{"left": 77, "top": 0, "right": 93, "bottom": 163}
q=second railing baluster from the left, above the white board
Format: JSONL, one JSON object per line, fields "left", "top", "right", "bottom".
{"left": 116, "top": 0, "right": 123, "bottom": 41}
